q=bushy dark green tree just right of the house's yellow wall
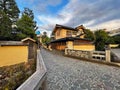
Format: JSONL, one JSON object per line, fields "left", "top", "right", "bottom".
{"left": 95, "top": 30, "right": 108, "bottom": 51}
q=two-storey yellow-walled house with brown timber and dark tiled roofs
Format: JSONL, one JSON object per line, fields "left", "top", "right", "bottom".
{"left": 49, "top": 25, "right": 95, "bottom": 50}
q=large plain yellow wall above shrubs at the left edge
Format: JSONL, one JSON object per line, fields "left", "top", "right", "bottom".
{"left": 0, "top": 46, "right": 28, "bottom": 67}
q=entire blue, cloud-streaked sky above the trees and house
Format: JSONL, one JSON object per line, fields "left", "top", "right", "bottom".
{"left": 16, "top": 0, "right": 120, "bottom": 34}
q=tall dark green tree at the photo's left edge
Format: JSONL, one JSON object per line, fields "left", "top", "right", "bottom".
{"left": 0, "top": 0, "right": 20, "bottom": 40}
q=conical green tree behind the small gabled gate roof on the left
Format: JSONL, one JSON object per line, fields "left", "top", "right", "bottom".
{"left": 17, "top": 9, "right": 36, "bottom": 39}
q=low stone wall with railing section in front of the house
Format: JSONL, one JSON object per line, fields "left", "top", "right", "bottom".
{"left": 65, "top": 49, "right": 109, "bottom": 61}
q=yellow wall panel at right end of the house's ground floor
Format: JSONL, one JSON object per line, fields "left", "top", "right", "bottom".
{"left": 74, "top": 45, "right": 95, "bottom": 51}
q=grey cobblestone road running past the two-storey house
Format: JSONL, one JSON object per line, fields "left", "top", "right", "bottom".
{"left": 41, "top": 49, "right": 120, "bottom": 90}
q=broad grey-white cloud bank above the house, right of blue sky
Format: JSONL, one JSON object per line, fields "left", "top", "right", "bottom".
{"left": 38, "top": 0, "right": 120, "bottom": 31}
